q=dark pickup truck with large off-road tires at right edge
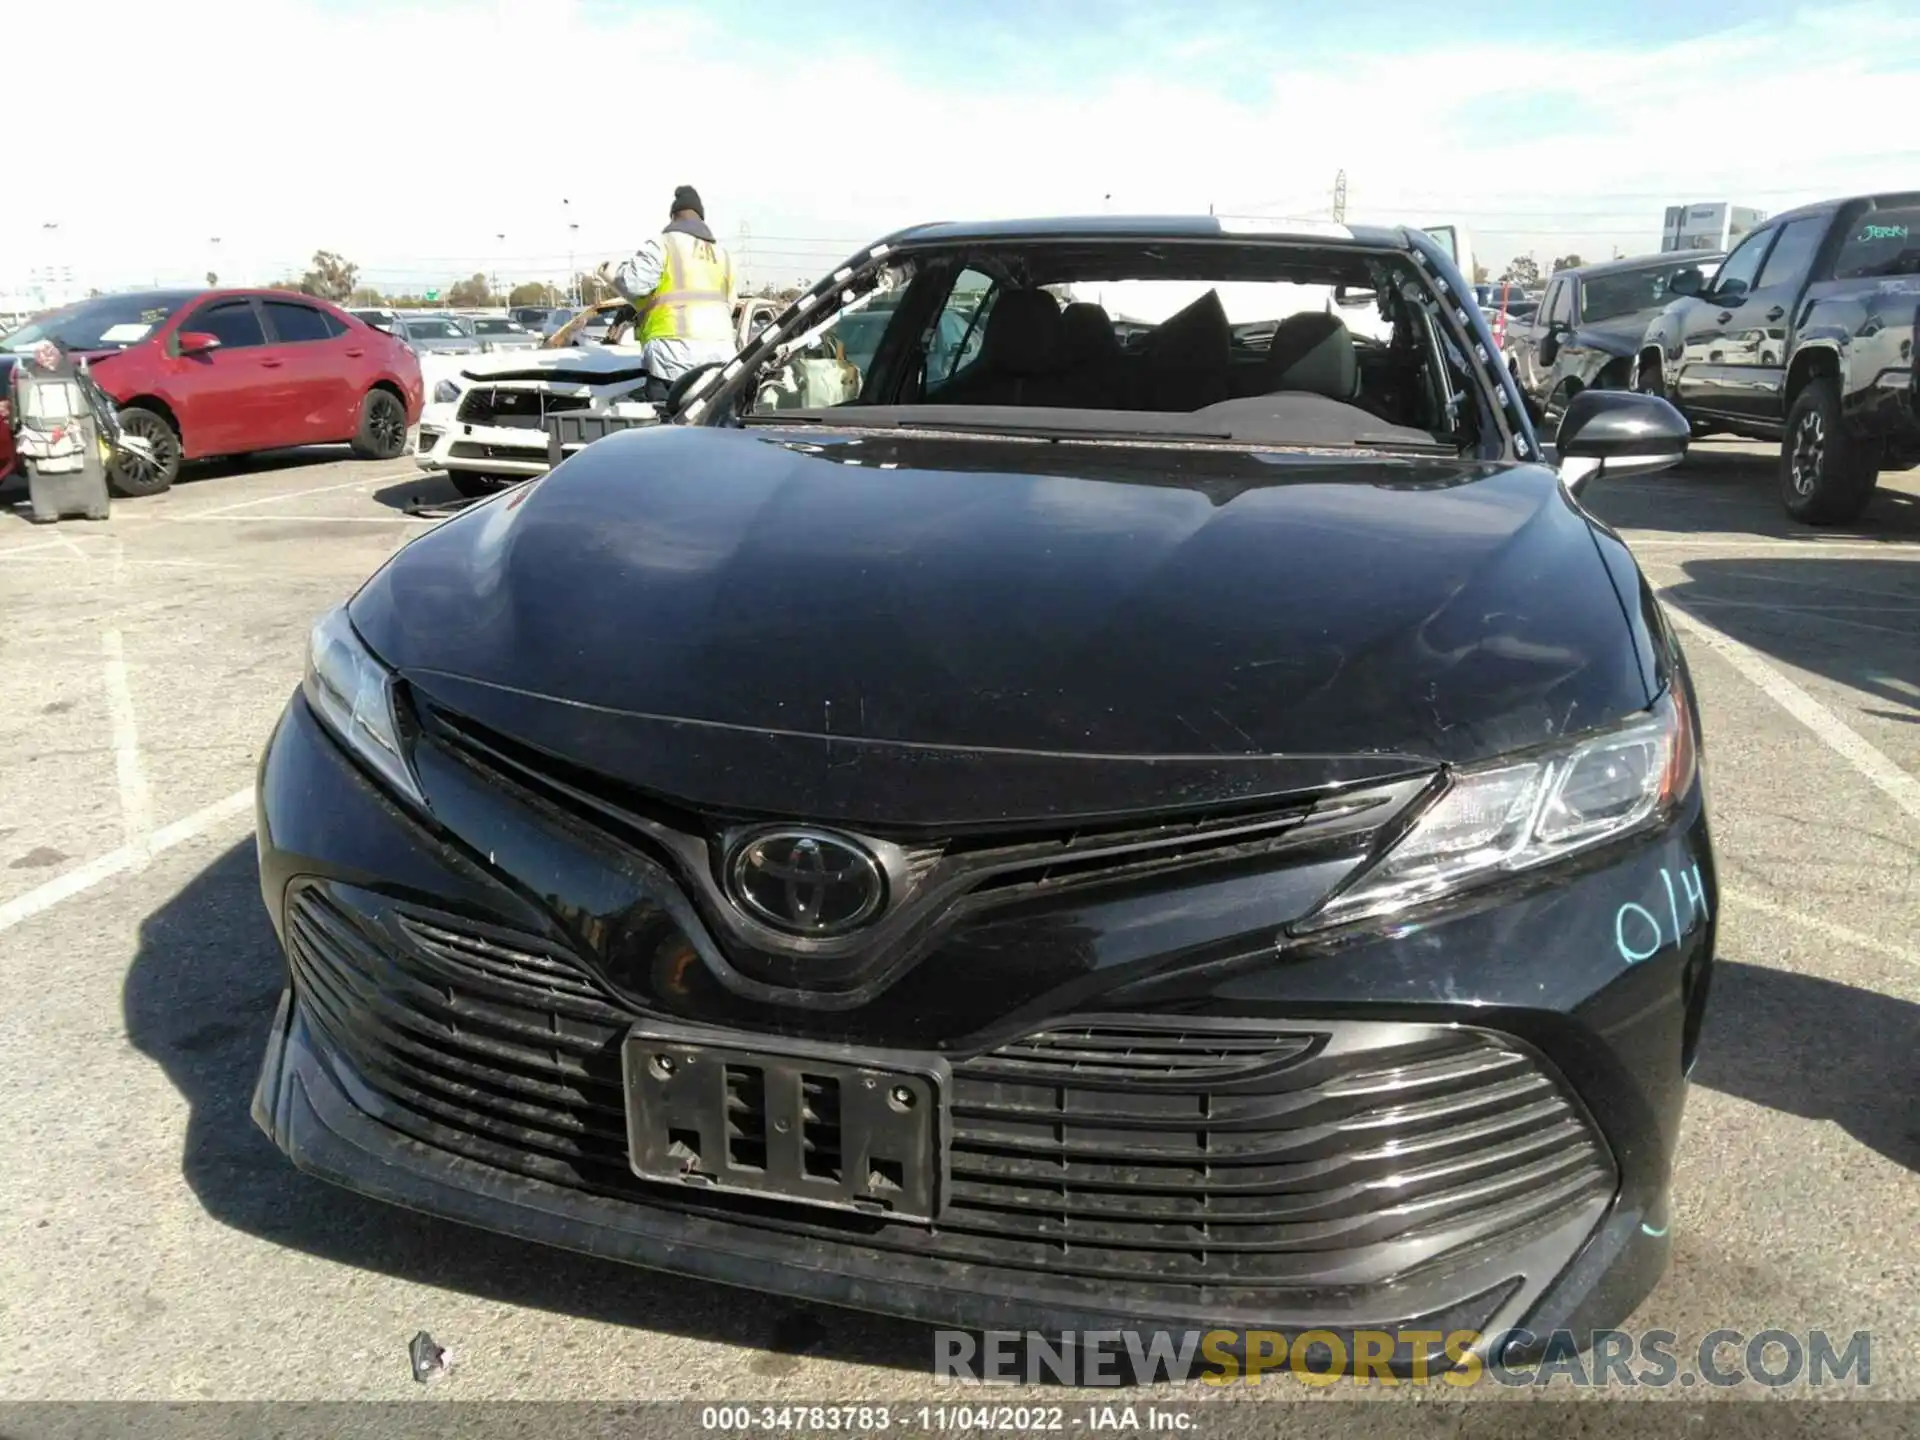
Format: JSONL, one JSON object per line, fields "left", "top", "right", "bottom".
{"left": 1634, "top": 192, "right": 1920, "bottom": 524}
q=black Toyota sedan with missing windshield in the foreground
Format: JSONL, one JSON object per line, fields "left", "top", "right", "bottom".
{"left": 253, "top": 217, "right": 1716, "bottom": 1359}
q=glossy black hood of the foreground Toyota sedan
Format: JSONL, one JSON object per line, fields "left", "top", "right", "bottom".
{"left": 351, "top": 426, "right": 1651, "bottom": 824}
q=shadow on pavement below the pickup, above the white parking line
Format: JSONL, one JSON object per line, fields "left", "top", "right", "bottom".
{"left": 1661, "top": 555, "right": 1920, "bottom": 724}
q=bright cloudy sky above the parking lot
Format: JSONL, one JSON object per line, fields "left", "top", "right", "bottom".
{"left": 0, "top": 0, "right": 1920, "bottom": 296}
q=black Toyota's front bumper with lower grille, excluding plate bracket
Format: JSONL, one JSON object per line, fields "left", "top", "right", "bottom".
{"left": 253, "top": 697, "right": 1713, "bottom": 1367}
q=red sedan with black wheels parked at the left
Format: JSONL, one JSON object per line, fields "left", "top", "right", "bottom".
{"left": 0, "top": 290, "right": 420, "bottom": 495}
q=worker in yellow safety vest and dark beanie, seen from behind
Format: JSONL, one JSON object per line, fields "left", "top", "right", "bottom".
{"left": 601, "top": 184, "right": 739, "bottom": 403}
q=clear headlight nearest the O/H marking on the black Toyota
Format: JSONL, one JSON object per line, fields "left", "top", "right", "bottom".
{"left": 1294, "top": 689, "right": 1695, "bottom": 931}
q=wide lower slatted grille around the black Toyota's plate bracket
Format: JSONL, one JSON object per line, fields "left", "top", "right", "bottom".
{"left": 286, "top": 885, "right": 1615, "bottom": 1317}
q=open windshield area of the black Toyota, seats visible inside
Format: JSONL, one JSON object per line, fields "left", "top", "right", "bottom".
{"left": 716, "top": 238, "right": 1503, "bottom": 453}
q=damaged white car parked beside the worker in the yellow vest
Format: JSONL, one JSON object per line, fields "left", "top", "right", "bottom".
{"left": 419, "top": 300, "right": 778, "bottom": 495}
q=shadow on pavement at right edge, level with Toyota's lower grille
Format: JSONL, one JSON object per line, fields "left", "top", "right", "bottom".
{"left": 1693, "top": 960, "right": 1920, "bottom": 1173}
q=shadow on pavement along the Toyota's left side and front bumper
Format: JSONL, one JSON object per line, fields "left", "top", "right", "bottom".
{"left": 121, "top": 837, "right": 933, "bottom": 1379}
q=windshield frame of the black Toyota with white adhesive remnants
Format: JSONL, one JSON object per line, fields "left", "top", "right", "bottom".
{"left": 670, "top": 228, "right": 1544, "bottom": 461}
